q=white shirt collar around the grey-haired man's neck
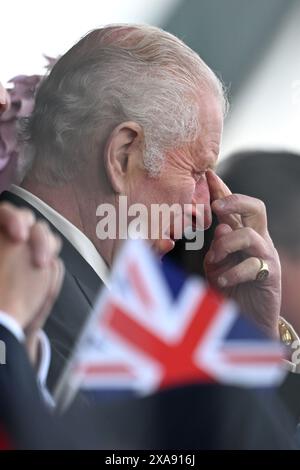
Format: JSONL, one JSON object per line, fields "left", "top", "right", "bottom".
{"left": 9, "top": 184, "right": 109, "bottom": 285}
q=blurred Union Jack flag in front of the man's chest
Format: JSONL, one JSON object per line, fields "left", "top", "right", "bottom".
{"left": 62, "top": 240, "right": 285, "bottom": 402}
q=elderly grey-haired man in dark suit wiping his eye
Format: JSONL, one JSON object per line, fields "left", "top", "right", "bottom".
{"left": 3, "top": 25, "right": 280, "bottom": 390}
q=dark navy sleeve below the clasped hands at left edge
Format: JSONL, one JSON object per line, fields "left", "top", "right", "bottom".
{"left": 0, "top": 325, "right": 76, "bottom": 449}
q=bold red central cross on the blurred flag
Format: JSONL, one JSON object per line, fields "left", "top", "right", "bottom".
{"left": 100, "top": 289, "right": 224, "bottom": 388}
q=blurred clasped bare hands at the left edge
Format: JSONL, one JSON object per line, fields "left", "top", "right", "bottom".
{"left": 0, "top": 203, "right": 64, "bottom": 360}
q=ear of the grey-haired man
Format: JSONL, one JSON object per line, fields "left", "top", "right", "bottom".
{"left": 104, "top": 121, "right": 144, "bottom": 194}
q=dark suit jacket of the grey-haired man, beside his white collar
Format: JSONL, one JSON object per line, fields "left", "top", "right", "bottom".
{"left": 0, "top": 191, "right": 102, "bottom": 393}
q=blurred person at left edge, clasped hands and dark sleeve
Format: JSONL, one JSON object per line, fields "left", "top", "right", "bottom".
{"left": 0, "top": 203, "right": 64, "bottom": 448}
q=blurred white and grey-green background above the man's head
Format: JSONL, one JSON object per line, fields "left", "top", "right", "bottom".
{"left": 0, "top": 0, "right": 300, "bottom": 157}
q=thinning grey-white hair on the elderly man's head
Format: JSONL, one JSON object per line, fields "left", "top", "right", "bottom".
{"left": 23, "top": 25, "right": 227, "bottom": 183}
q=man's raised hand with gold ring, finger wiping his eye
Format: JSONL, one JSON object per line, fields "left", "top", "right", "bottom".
{"left": 204, "top": 171, "right": 281, "bottom": 338}
